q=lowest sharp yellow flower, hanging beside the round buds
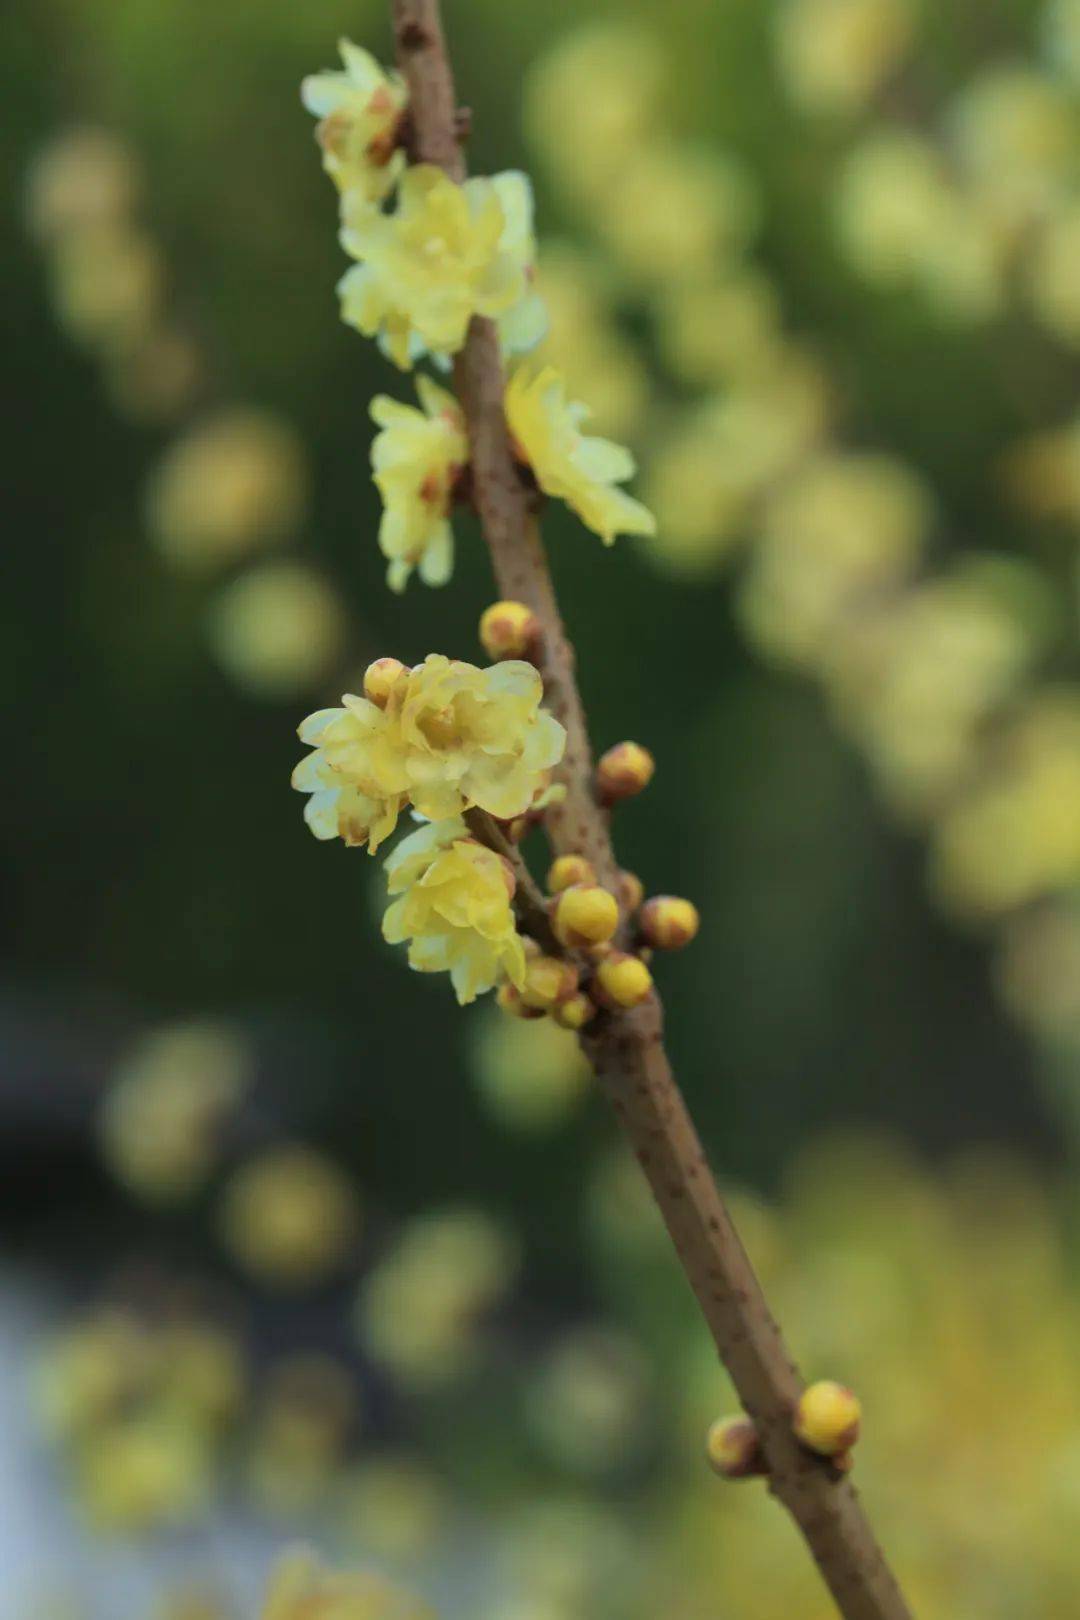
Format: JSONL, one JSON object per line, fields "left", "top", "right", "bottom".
{"left": 382, "top": 816, "right": 525, "bottom": 1006}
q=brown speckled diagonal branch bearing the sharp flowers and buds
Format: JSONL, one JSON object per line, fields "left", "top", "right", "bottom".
{"left": 392, "top": 0, "right": 910, "bottom": 1620}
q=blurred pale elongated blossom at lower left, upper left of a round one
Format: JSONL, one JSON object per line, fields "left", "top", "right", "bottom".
{"left": 99, "top": 1022, "right": 249, "bottom": 1202}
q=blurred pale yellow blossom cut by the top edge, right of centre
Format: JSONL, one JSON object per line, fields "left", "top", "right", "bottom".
{"left": 776, "top": 0, "right": 915, "bottom": 113}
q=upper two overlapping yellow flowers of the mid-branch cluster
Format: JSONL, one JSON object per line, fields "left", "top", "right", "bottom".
{"left": 293, "top": 653, "right": 567, "bottom": 854}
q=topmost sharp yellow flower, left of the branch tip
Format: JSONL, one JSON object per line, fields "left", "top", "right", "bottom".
{"left": 300, "top": 39, "right": 408, "bottom": 206}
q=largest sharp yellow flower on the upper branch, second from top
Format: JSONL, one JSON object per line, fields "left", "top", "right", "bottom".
{"left": 338, "top": 164, "right": 542, "bottom": 371}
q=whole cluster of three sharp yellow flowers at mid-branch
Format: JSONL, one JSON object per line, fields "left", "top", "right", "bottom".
{"left": 293, "top": 654, "right": 565, "bottom": 1003}
